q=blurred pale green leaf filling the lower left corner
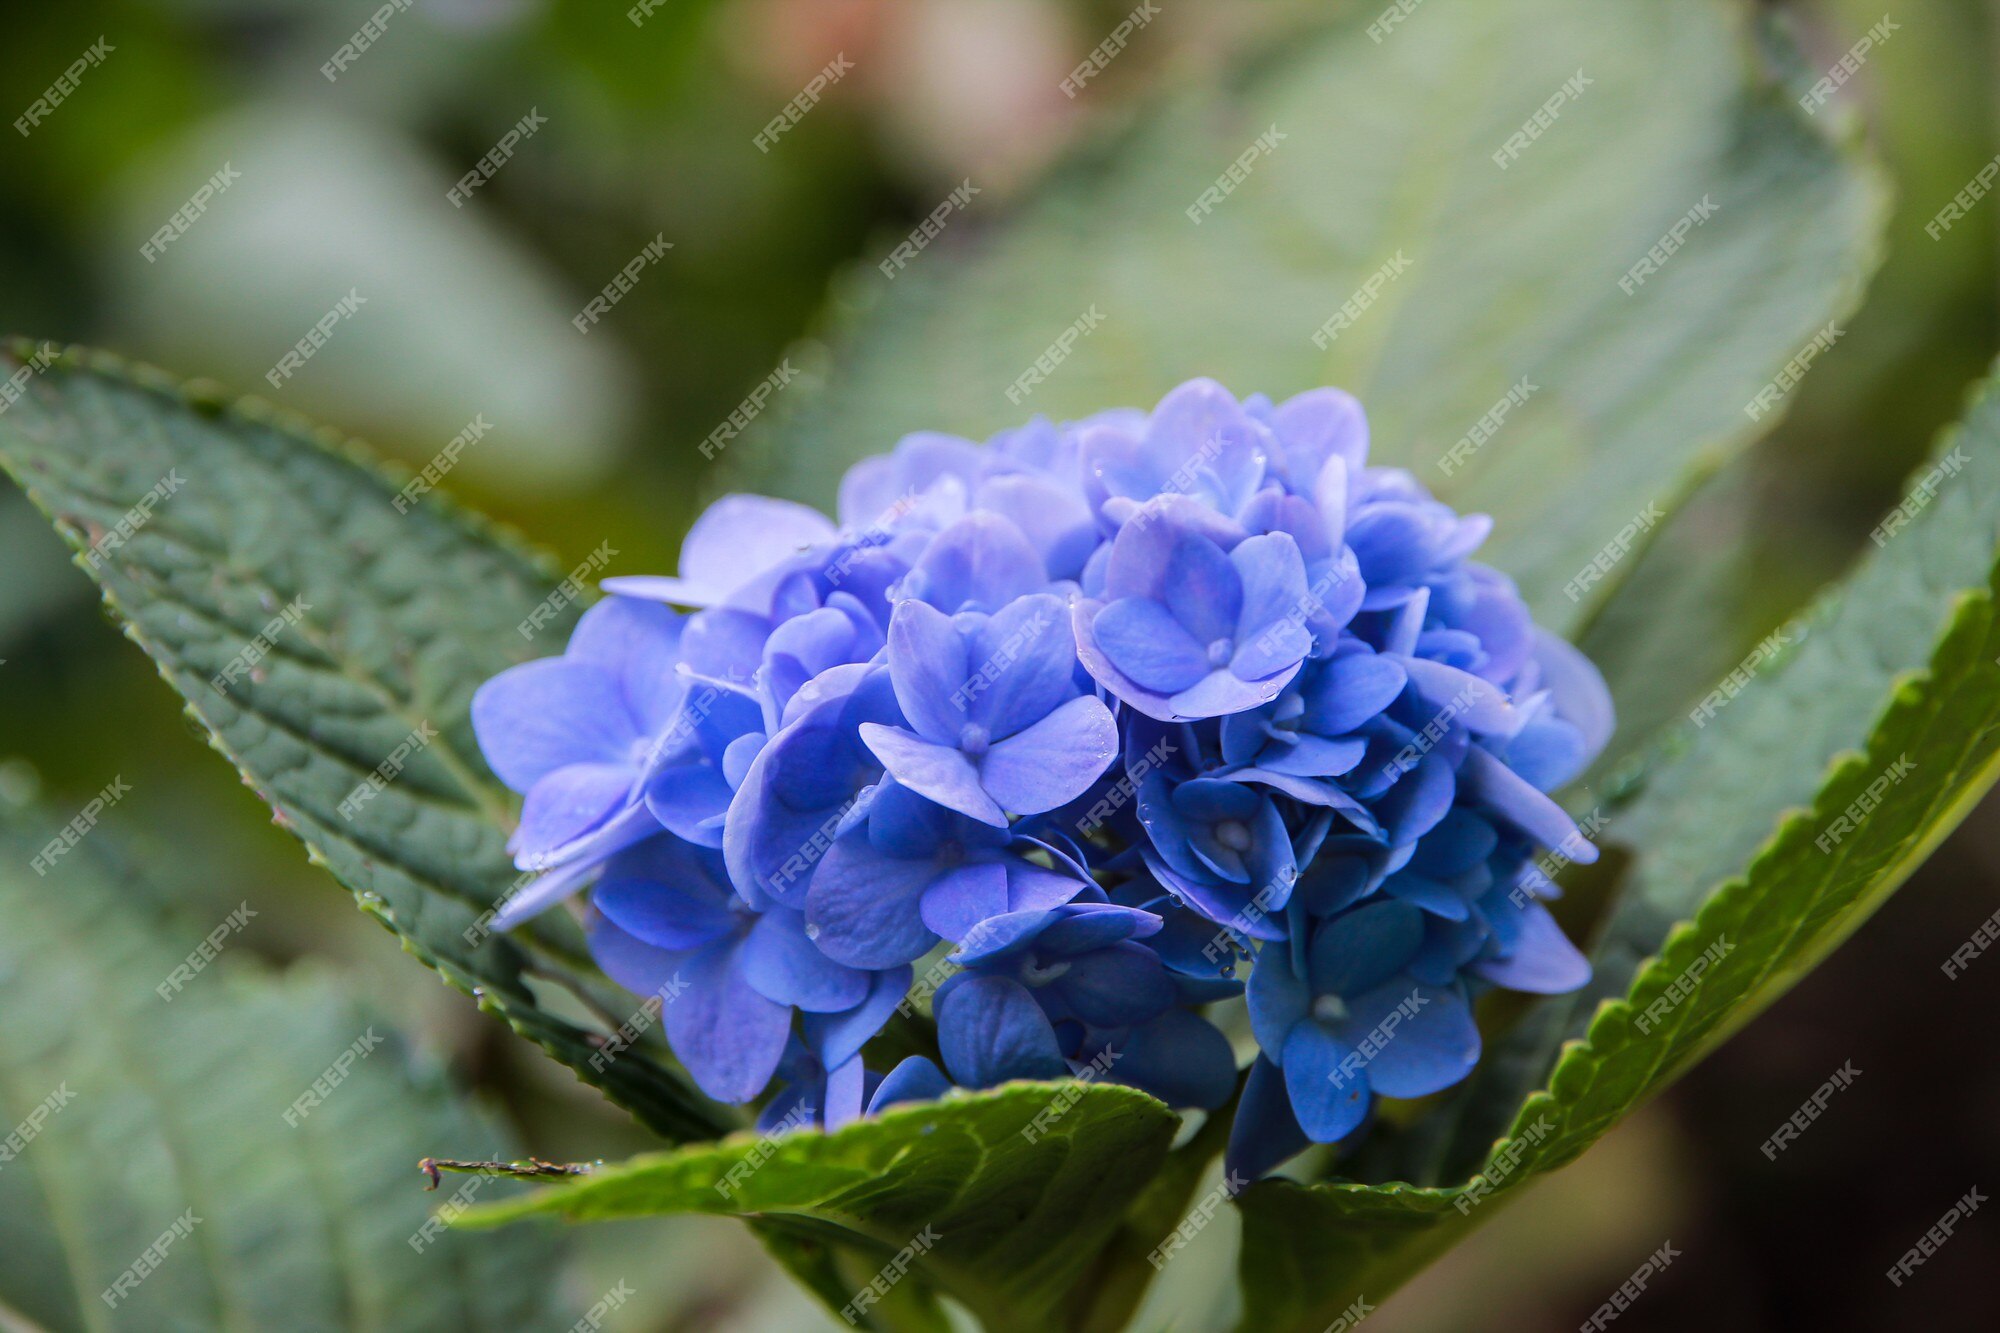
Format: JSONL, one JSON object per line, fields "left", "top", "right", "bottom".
{"left": 0, "top": 811, "right": 570, "bottom": 1333}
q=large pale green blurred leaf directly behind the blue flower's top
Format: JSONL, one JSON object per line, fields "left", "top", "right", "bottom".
{"left": 736, "top": 0, "right": 1886, "bottom": 630}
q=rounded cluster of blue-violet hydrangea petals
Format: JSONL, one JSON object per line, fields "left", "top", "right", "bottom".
{"left": 472, "top": 380, "right": 1612, "bottom": 1175}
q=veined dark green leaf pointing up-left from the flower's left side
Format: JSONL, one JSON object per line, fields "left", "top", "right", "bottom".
{"left": 0, "top": 344, "right": 734, "bottom": 1141}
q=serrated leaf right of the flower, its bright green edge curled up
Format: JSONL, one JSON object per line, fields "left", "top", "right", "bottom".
{"left": 1242, "top": 366, "right": 2000, "bottom": 1327}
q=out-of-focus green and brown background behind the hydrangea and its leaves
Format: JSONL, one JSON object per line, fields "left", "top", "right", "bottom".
{"left": 0, "top": 0, "right": 2000, "bottom": 1333}
